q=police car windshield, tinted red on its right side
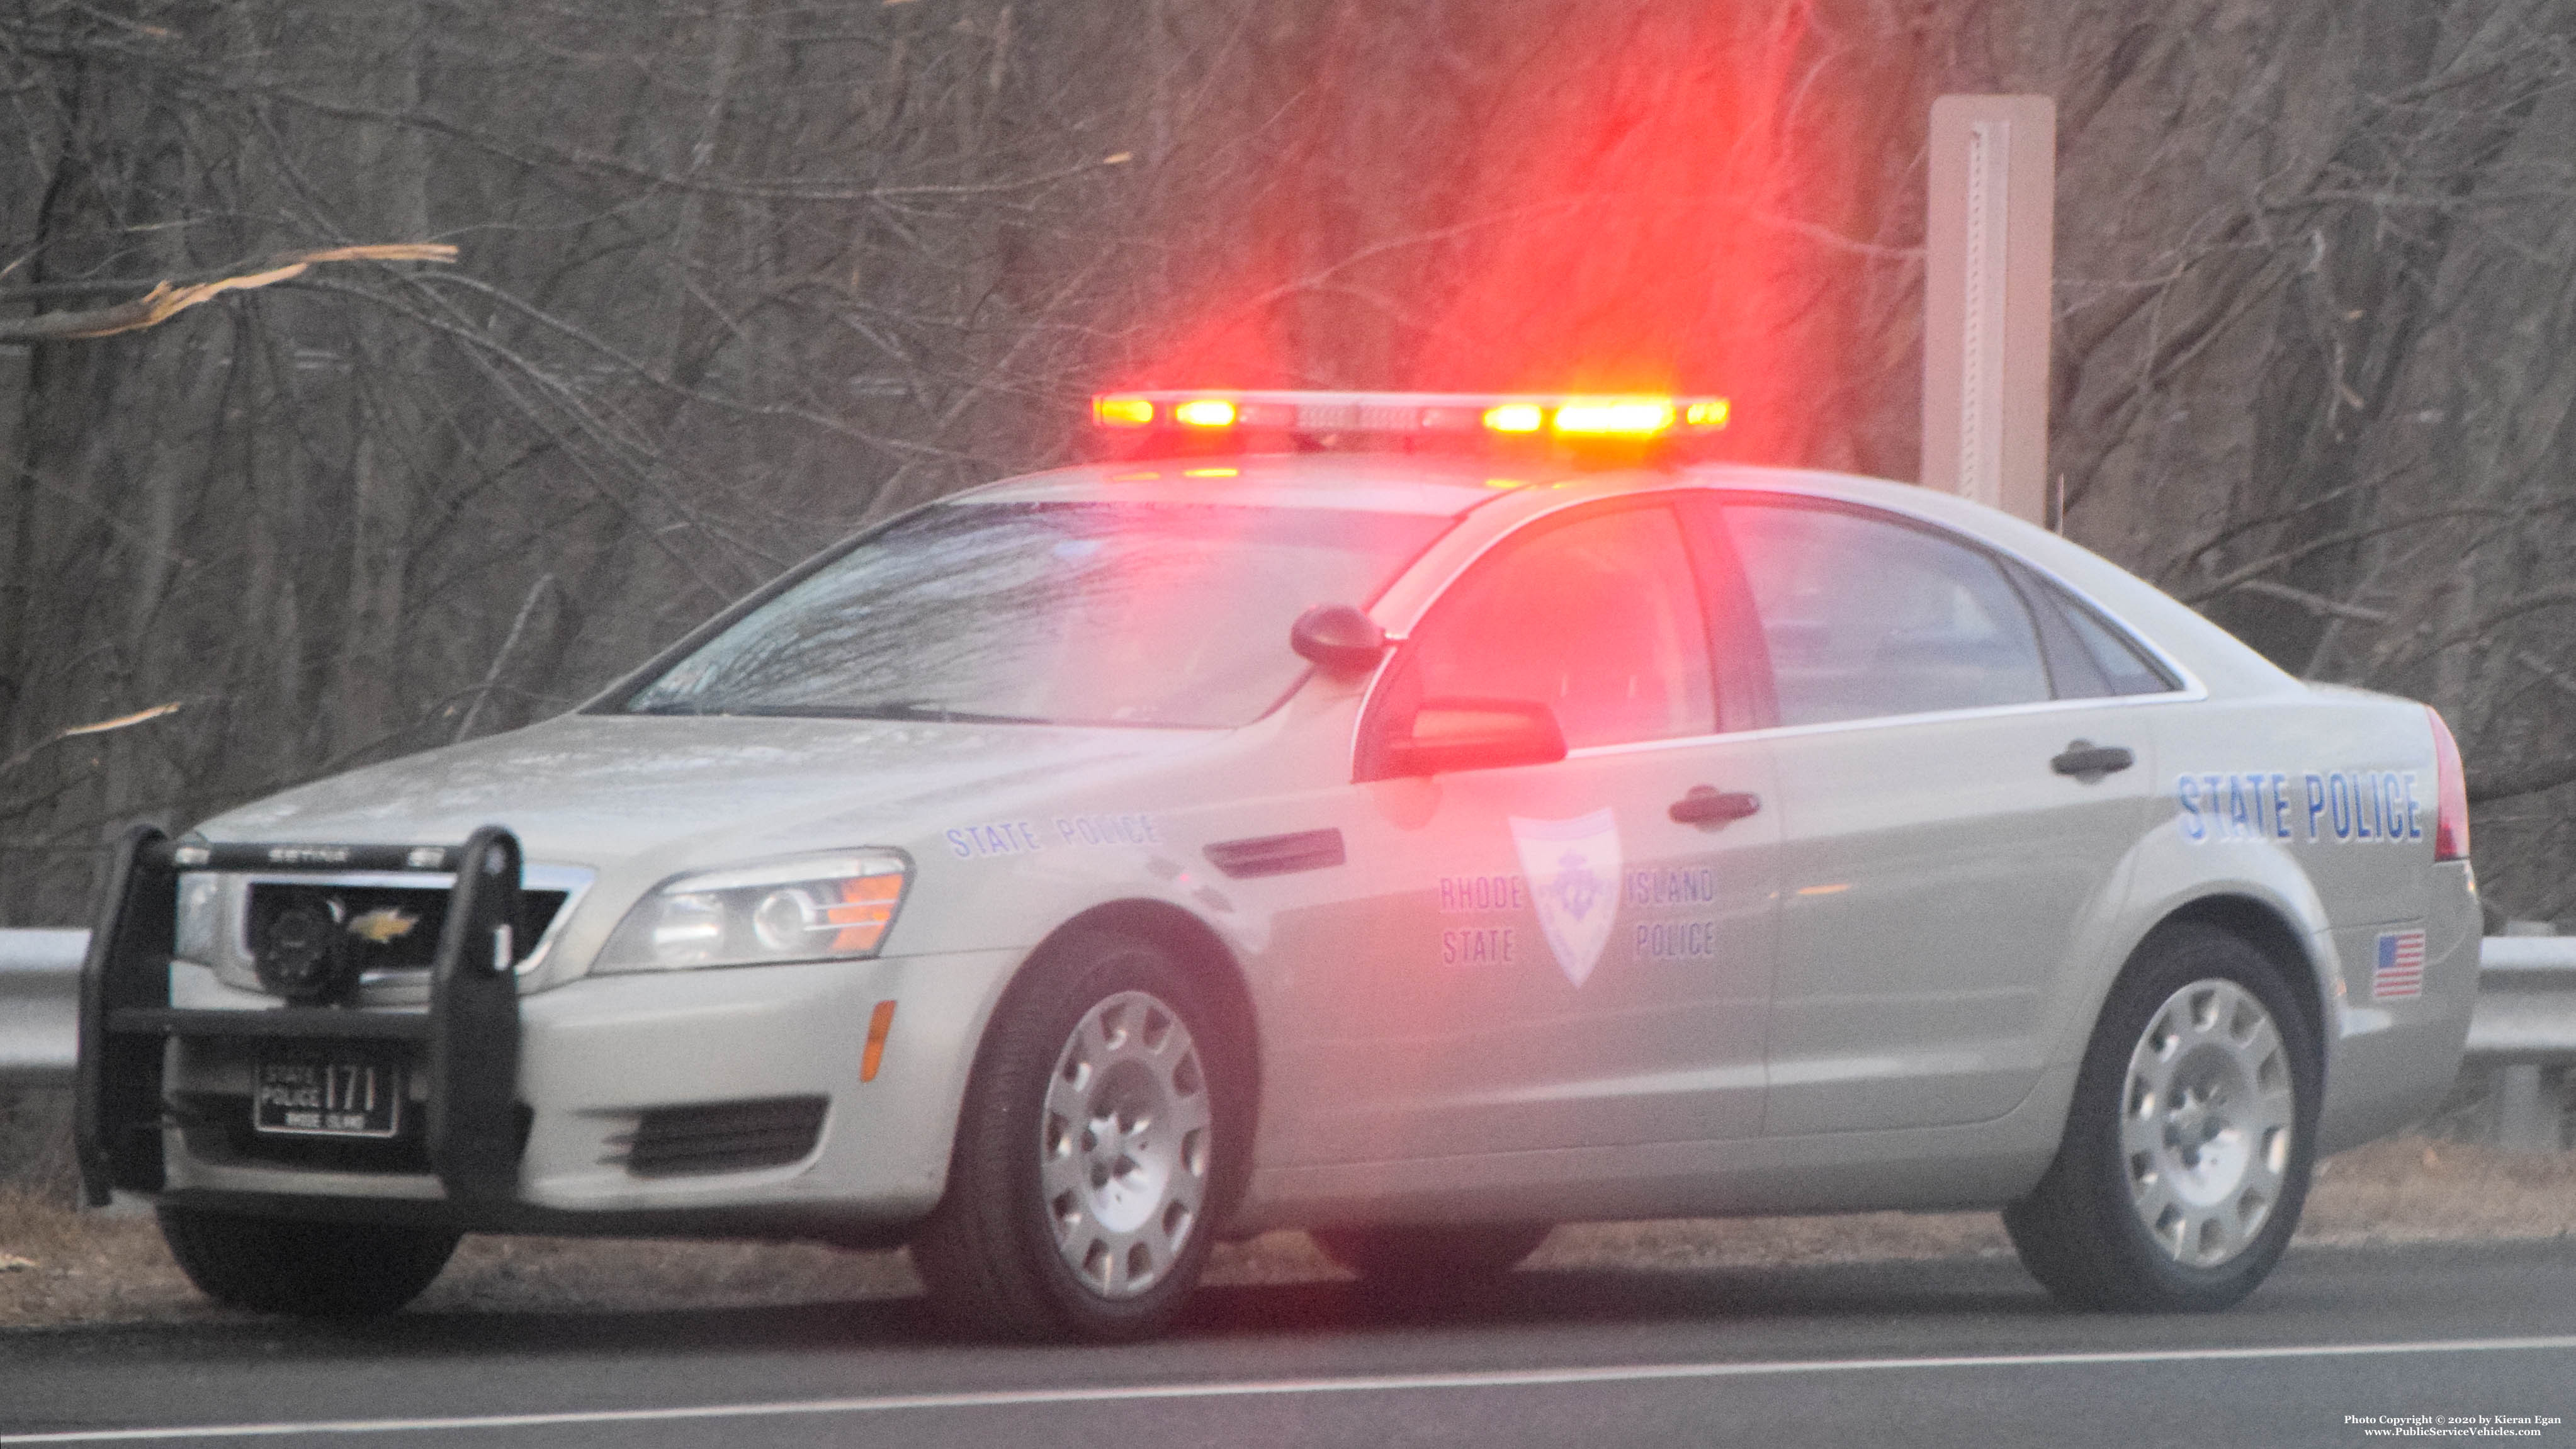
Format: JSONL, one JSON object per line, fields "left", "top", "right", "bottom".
{"left": 623, "top": 502, "right": 1450, "bottom": 726}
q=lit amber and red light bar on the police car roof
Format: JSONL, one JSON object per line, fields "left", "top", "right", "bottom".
{"left": 1092, "top": 388, "right": 1729, "bottom": 443}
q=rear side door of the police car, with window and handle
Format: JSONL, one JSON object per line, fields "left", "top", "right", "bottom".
{"left": 1726, "top": 499, "right": 2172, "bottom": 1135}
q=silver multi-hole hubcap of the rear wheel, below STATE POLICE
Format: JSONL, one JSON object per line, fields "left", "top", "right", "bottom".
{"left": 2120, "top": 978, "right": 2298, "bottom": 1269}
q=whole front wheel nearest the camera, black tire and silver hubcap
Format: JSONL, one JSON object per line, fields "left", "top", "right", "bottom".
{"left": 912, "top": 932, "right": 1250, "bottom": 1341}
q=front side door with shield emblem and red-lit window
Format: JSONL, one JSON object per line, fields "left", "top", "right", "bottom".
{"left": 1275, "top": 502, "right": 1777, "bottom": 1161}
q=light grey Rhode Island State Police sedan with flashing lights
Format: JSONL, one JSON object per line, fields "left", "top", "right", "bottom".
{"left": 77, "top": 394, "right": 2478, "bottom": 1338}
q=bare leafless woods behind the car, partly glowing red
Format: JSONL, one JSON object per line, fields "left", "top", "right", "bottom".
{"left": 0, "top": 0, "right": 2576, "bottom": 924}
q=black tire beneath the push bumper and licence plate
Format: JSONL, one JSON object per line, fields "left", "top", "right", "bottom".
{"left": 160, "top": 1207, "right": 456, "bottom": 1317}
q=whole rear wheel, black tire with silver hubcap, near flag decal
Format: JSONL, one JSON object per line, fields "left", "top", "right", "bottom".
{"left": 2004, "top": 922, "right": 2324, "bottom": 1312}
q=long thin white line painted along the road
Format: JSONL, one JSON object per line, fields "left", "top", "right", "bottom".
{"left": 0, "top": 1336, "right": 2576, "bottom": 1444}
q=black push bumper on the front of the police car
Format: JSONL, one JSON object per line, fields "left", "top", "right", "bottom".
{"left": 72, "top": 826, "right": 536, "bottom": 1205}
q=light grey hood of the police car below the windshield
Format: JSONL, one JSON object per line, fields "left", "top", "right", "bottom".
{"left": 201, "top": 716, "right": 1203, "bottom": 865}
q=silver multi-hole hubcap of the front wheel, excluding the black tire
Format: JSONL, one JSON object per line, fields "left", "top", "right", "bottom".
{"left": 1038, "top": 991, "right": 1213, "bottom": 1300}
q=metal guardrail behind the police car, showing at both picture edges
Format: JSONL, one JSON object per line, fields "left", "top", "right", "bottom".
{"left": 0, "top": 932, "right": 2576, "bottom": 1151}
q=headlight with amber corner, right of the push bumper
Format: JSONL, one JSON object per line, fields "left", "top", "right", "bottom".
{"left": 590, "top": 849, "right": 912, "bottom": 973}
